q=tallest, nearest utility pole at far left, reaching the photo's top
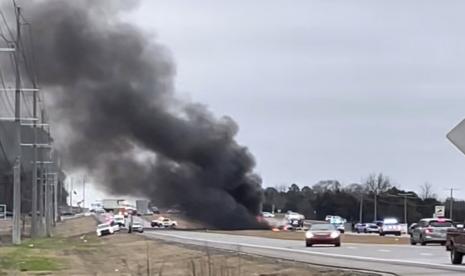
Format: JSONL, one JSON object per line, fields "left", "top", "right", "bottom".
{"left": 12, "top": 5, "right": 21, "bottom": 244}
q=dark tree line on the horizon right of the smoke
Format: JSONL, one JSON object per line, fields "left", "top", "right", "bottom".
{"left": 263, "top": 173, "right": 465, "bottom": 224}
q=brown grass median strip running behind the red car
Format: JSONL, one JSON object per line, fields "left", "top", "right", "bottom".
{"left": 209, "top": 230, "right": 409, "bottom": 244}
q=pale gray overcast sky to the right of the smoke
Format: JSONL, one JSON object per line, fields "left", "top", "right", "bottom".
{"left": 102, "top": 0, "right": 465, "bottom": 201}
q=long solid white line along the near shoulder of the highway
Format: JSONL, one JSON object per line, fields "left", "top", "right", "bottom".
{"left": 146, "top": 232, "right": 465, "bottom": 271}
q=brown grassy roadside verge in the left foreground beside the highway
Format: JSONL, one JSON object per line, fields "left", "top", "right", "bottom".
{"left": 0, "top": 217, "right": 376, "bottom": 276}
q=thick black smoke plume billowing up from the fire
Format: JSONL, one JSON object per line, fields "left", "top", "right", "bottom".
{"left": 23, "top": 0, "right": 262, "bottom": 228}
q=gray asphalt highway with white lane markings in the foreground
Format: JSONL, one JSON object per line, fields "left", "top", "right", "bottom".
{"left": 144, "top": 230, "right": 465, "bottom": 275}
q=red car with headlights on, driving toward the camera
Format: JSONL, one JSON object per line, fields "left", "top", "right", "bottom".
{"left": 305, "top": 223, "right": 341, "bottom": 247}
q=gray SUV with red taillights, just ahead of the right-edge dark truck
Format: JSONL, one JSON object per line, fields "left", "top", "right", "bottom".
{"left": 410, "top": 218, "right": 455, "bottom": 245}
